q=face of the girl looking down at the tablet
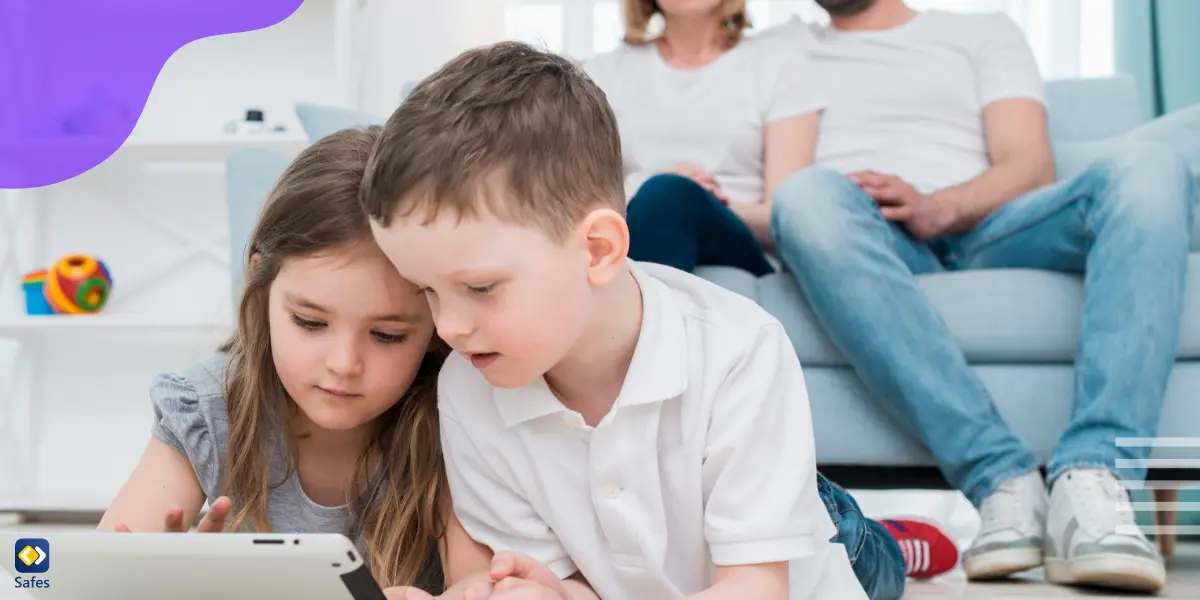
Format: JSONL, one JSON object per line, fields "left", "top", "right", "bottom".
{"left": 269, "top": 242, "right": 433, "bottom": 431}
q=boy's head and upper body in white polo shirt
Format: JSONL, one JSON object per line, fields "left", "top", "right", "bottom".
{"left": 361, "top": 43, "right": 892, "bottom": 600}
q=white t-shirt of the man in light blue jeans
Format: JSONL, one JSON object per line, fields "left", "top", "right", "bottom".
{"left": 763, "top": 11, "right": 1044, "bottom": 193}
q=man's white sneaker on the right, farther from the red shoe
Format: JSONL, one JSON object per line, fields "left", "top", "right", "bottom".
{"left": 1045, "top": 469, "right": 1166, "bottom": 592}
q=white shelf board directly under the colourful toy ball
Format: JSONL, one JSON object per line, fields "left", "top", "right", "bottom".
{"left": 0, "top": 314, "right": 233, "bottom": 342}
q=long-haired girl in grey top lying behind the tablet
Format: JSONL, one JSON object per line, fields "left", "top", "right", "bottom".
{"left": 100, "top": 128, "right": 490, "bottom": 594}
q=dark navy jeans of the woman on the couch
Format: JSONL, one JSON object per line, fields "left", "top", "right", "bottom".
{"left": 625, "top": 174, "right": 775, "bottom": 276}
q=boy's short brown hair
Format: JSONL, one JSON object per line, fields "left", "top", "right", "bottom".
{"left": 360, "top": 42, "right": 625, "bottom": 241}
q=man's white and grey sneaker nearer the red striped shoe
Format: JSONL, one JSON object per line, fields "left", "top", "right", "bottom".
{"left": 962, "top": 470, "right": 1048, "bottom": 580}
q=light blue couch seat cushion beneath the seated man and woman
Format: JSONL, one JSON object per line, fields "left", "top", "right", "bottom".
{"left": 697, "top": 254, "right": 1200, "bottom": 366}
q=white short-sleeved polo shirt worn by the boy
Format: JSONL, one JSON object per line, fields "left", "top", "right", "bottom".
{"left": 438, "top": 262, "right": 865, "bottom": 600}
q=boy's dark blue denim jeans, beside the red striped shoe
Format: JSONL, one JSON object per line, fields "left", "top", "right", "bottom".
{"left": 817, "top": 473, "right": 908, "bottom": 600}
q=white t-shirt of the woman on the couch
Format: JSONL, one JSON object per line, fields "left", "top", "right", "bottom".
{"left": 584, "top": 36, "right": 824, "bottom": 203}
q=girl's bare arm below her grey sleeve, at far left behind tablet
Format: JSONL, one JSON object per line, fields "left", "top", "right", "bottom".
{"left": 97, "top": 437, "right": 205, "bottom": 532}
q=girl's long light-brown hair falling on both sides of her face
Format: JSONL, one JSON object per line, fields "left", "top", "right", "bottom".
{"left": 223, "top": 127, "right": 448, "bottom": 586}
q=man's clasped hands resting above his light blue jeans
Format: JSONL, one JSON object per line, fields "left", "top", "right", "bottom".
{"left": 847, "top": 170, "right": 958, "bottom": 240}
